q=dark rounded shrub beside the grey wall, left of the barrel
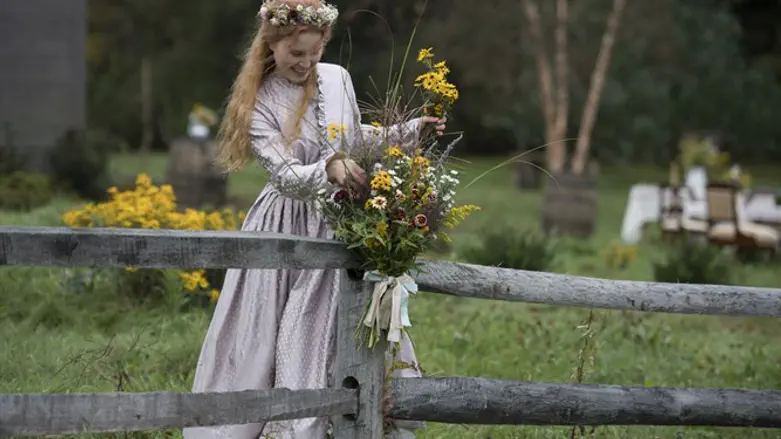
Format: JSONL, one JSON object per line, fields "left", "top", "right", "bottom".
{"left": 49, "top": 130, "right": 117, "bottom": 200}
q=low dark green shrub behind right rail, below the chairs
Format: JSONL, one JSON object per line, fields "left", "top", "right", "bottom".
{"left": 654, "top": 241, "right": 737, "bottom": 285}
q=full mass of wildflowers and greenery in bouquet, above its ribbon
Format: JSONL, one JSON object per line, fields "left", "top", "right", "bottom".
{"left": 321, "top": 145, "right": 479, "bottom": 277}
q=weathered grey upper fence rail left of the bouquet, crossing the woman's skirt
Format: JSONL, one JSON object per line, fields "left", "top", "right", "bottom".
{"left": 0, "top": 226, "right": 358, "bottom": 268}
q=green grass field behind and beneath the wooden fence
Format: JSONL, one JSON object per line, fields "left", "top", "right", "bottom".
{"left": 0, "top": 152, "right": 781, "bottom": 439}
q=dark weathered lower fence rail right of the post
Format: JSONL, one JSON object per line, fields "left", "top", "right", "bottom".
{"left": 391, "top": 377, "right": 781, "bottom": 427}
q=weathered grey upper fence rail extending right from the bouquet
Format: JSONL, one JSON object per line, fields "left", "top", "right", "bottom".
{"left": 412, "top": 261, "right": 781, "bottom": 317}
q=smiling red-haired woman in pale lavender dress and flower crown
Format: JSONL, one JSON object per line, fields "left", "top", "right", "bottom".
{"left": 184, "top": 0, "right": 445, "bottom": 439}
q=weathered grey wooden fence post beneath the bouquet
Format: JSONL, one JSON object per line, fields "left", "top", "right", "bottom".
{"left": 331, "top": 270, "right": 387, "bottom": 439}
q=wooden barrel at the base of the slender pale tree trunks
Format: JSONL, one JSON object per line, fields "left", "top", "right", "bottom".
{"left": 542, "top": 174, "right": 597, "bottom": 238}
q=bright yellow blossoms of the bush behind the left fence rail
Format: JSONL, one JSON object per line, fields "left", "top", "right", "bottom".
{"left": 62, "top": 174, "right": 244, "bottom": 301}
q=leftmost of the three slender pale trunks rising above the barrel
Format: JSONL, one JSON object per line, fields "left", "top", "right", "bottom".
{"left": 523, "top": 0, "right": 567, "bottom": 173}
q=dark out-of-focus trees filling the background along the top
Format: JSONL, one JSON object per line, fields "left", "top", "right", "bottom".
{"left": 89, "top": 0, "right": 781, "bottom": 163}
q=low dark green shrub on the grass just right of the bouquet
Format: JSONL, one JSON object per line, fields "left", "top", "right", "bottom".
{"left": 462, "top": 226, "right": 558, "bottom": 271}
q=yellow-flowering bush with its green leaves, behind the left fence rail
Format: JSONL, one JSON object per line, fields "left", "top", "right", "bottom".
{"left": 62, "top": 174, "right": 244, "bottom": 302}
